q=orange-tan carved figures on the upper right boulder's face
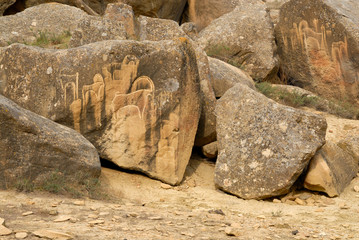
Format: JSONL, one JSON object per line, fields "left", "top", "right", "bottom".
{"left": 282, "top": 19, "right": 359, "bottom": 85}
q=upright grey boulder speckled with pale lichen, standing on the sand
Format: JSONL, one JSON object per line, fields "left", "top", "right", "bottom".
{"left": 215, "top": 84, "right": 327, "bottom": 199}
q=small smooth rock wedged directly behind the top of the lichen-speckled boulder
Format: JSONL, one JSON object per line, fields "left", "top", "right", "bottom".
{"left": 208, "top": 57, "right": 256, "bottom": 98}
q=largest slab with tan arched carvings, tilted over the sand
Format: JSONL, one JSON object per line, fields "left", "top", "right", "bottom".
{"left": 0, "top": 39, "right": 200, "bottom": 184}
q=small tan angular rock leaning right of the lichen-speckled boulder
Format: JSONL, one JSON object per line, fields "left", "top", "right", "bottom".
{"left": 304, "top": 142, "right": 359, "bottom": 197}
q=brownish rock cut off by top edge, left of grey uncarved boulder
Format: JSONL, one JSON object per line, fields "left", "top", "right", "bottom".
{"left": 184, "top": 0, "right": 243, "bottom": 31}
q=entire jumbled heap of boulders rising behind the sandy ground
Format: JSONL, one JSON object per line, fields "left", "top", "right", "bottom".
{"left": 0, "top": 0, "right": 359, "bottom": 236}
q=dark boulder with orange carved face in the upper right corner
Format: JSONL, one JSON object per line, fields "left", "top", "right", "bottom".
{"left": 276, "top": 0, "right": 359, "bottom": 104}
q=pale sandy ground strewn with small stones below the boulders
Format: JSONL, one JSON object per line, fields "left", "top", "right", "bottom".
{"left": 0, "top": 156, "right": 359, "bottom": 240}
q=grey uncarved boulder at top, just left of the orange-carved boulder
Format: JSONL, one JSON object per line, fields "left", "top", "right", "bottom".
{"left": 197, "top": 0, "right": 277, "bottom": 80}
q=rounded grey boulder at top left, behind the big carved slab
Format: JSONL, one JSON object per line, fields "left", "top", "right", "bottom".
{"left": 0, "top": 4, "right": 87, "bottom": 47}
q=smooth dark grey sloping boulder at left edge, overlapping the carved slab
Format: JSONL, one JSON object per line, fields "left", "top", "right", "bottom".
{"left": 0, "top": 95, "right": 101, "bottom": 188}
